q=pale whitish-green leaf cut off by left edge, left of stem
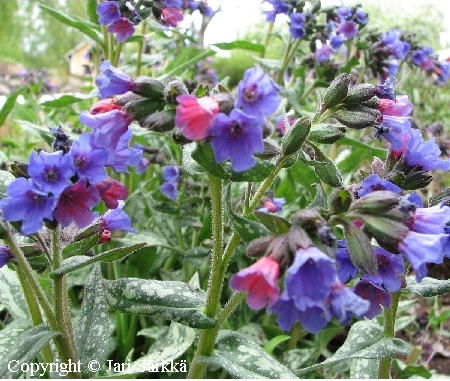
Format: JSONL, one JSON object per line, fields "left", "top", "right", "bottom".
{"left": 0, "top": 266, "right": 29, "bottom": 319}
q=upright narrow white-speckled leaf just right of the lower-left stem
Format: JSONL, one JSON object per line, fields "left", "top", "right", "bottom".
{"left": 74, "top": 264, "right": 110, "bottom": 378}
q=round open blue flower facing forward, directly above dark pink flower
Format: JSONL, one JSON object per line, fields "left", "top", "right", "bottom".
{"left": 28, "top": 151, "right": 75, "bottom": 197}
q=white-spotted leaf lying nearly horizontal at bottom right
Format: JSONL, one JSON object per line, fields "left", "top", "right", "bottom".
{"left": 300, "top": 320, "right": 409, "bottom": 373}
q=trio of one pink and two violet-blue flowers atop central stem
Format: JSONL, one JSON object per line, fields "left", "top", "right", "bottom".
{"left": 175, "top": 66, "right": 280, "bottom": 172}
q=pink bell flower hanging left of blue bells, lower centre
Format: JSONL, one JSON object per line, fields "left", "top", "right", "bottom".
{"left": 230, "top": 256, "right": 280, "bottom": 310}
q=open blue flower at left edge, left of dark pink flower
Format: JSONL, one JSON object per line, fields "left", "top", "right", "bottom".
{"left": 0, "top": 177, "right": 56, "bottom": 234}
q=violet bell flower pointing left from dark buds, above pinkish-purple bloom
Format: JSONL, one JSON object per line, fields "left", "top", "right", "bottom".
{"left": 95, "top": 60, "right": 136, "bottom": 99}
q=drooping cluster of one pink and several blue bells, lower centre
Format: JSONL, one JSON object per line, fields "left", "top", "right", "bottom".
{"left": 230, "top": 227, "right": 369, "bottom": 333}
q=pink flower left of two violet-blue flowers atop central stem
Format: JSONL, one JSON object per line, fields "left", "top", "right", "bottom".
{"left": 175, "top": 94, "right": 219, "bottom": 140}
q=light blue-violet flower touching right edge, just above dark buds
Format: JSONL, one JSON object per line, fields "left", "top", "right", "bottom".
{"left": 402, "top": 129, "right": 450, "bottom": 171}
